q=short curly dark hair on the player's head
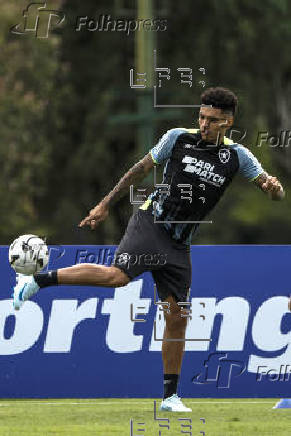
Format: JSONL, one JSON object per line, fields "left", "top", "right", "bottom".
{"left": 201, "top": 86, "right": 238, "bottom": 115}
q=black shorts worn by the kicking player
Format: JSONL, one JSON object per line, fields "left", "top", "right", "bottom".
{"left": 112, "top": 209, "right": 192, "bottom": 302}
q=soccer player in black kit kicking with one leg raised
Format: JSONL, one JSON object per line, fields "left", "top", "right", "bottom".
{"left": 13, "top": 87, "right": 284, "bottom": 412}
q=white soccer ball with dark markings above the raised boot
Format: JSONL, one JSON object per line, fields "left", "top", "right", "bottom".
{"left": 9, "top": 235, "right": 49, "bottom": 275}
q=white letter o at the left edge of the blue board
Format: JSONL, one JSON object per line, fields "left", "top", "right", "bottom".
{"left": 0, "top": 299, "right": 43, "bottom": 356}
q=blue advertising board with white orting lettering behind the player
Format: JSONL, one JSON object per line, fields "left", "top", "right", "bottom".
{"left": 0, "top": 245, "right": 291, "bottom": 398}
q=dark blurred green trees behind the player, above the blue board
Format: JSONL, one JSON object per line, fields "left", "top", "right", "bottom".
{"left": 0, "top": 0, "right": 291, "bottom": 244}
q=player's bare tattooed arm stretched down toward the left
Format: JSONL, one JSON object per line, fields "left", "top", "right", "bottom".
{"left": 79, "top": 153, "right": 155, "bottom": 230}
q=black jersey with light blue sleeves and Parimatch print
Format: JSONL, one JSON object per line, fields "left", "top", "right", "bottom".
{"left": 140, "top": 128, "right": 264, "bottom": 245}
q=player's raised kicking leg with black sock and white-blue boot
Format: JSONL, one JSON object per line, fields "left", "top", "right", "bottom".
{"left": 13, "top": 263, "right": 130, "bottom": 310}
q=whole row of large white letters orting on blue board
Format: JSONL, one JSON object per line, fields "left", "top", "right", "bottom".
{"left": 0, "top": 292, "right": 291, "bottom": 362}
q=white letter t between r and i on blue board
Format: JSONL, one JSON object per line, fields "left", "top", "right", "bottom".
{"left": 102, "top": 279, "right": 152, "bottom": 353}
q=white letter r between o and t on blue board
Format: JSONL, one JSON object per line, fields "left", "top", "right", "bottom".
{"left": 43, "top": 298, "right": 98, "bottom": 353}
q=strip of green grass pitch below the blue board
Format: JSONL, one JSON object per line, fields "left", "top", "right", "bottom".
{"left": 0, "top": 398, "right": 291, "bottom": 436}
